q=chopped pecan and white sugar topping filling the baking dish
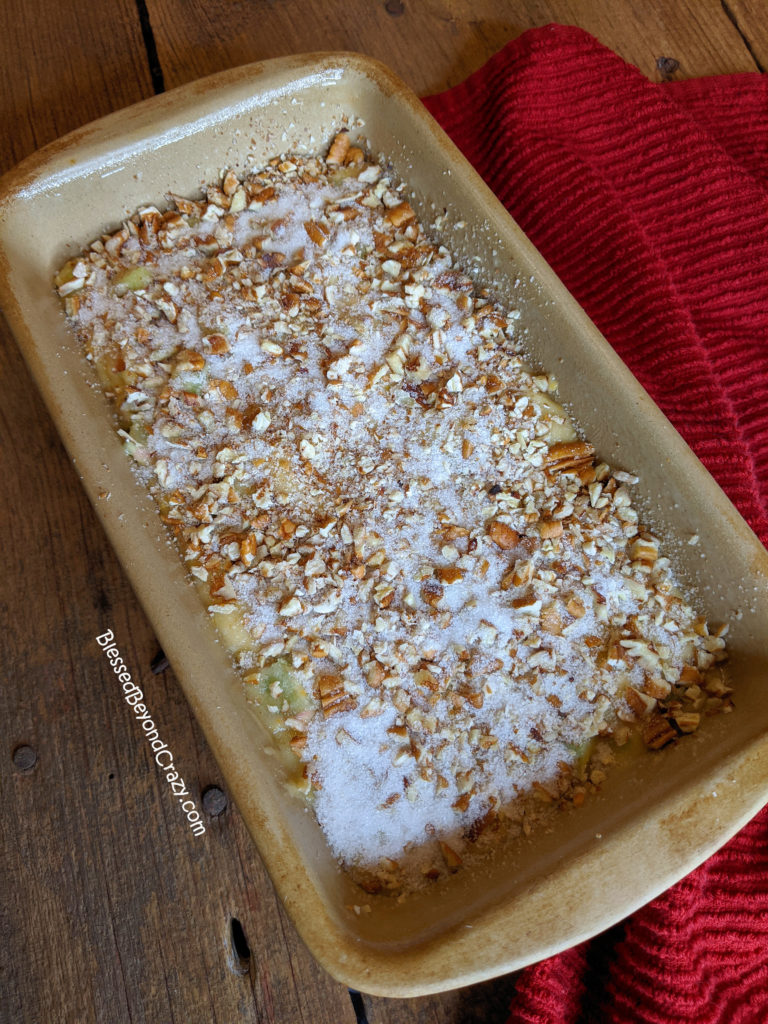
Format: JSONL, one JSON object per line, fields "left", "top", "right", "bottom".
{"left": 55, "top": 131, "right": 730, "bottom": 891}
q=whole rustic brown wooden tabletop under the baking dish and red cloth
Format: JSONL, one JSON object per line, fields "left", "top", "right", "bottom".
{"left": 0, "top": 0, "right": 768, "bottom": 1024}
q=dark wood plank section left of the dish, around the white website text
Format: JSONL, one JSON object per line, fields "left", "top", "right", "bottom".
{"left": 0, "top": 327, "right": 355, "bottom": 1024}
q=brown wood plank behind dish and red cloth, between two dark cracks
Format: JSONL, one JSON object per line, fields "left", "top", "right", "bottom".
{"left": 147, "top": 0, "right": 760, "bottom": 95}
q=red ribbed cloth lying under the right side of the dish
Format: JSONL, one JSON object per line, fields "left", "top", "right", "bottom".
{"left": 426, "top": 26, "right": 768, "bottom": 1024}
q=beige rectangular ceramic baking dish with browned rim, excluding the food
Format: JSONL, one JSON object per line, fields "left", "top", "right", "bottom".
{"left": 0, "top": 54, "right": 768, "bottom": 996}
